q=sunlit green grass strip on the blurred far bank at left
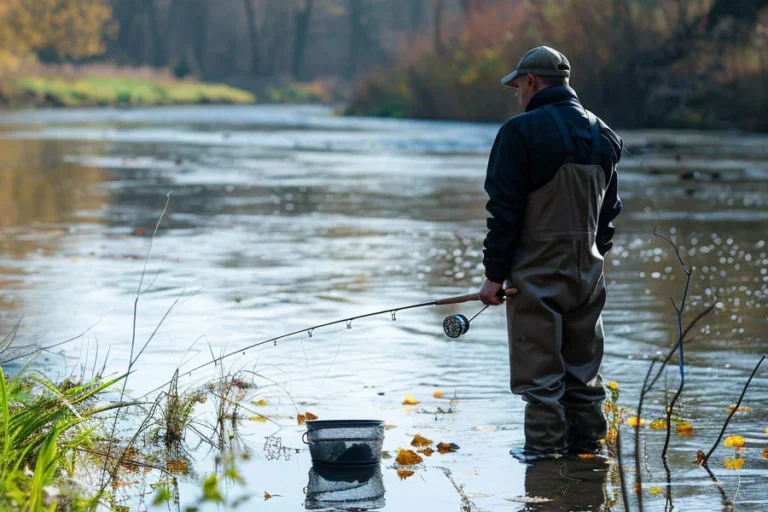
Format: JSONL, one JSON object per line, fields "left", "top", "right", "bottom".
{"left": 0, "top": 76, "right": 256, "bottom": 107}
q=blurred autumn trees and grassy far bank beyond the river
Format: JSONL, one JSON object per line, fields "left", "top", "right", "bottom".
{"left": 0, "top": 0, "right": 768, "bottom": 130}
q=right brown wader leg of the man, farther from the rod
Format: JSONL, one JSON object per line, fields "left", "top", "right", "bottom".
{"left": 560, "top": 283, "right": 607, "bottom": 453}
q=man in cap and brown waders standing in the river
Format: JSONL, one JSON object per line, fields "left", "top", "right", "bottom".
{"left": 480, "top": 46, "right": 622, "bottom": 461}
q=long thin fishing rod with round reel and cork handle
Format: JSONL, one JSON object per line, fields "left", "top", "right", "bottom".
{"left": 144, "top": 288, "right": 517, "bottom": 396}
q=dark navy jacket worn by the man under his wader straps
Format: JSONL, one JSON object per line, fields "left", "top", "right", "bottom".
{"left": 483, "top": 86, "right": 623, "bottom": 283}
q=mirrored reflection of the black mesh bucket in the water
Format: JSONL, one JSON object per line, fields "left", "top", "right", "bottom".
{"left": 304, "top": 464, "right": 385, "bottom": 510}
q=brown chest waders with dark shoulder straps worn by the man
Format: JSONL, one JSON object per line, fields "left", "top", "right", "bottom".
{"left": 507, "top": 105, "right": 606, "bottom": 459}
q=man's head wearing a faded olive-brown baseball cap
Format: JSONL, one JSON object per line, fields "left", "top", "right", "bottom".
{"left": 501, "top": 46, "right": 571, "bottom": 108}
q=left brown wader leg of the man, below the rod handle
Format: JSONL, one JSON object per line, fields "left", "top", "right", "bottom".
{"left": 507, "top": 294, "right": 566, "bottom": 459}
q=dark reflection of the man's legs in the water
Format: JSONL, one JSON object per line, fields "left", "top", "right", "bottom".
{"left": 524, "top": 459, "right": 609, "bottom": 512}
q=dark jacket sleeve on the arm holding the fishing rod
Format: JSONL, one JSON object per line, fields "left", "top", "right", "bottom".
{"left": 483, "top": 122, "right": 529, "bottom": 283}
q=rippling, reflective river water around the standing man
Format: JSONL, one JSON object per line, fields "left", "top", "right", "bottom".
{"left": 0, "top": 106, "right": 768, "bottom": 511}
